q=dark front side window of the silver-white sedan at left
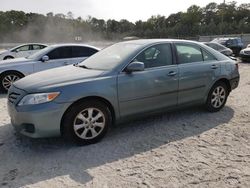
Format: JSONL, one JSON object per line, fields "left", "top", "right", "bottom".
{"left": 47, "top": 47, "right": 72, "bottom": 59}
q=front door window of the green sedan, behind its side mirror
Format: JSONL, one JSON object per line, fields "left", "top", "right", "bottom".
{"left": 134, "top": 44, "right": 172, "bottom": 68}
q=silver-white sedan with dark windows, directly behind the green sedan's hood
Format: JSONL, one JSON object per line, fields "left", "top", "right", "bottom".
{"left": 0, "top": 44, "right": 99, "bottom": 92}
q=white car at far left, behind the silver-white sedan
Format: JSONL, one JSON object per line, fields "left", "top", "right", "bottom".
{"left": 0, "top": 43, "right": 47, "bottom": 60}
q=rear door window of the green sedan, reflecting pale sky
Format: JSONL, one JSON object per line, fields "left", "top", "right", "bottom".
{"left": 176, "top": 44, "right": 203, "bottom": 64}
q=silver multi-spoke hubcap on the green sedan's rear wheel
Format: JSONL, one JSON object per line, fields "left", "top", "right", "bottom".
{"left": 211, "top": 86, "right": 226, "bottom": 108}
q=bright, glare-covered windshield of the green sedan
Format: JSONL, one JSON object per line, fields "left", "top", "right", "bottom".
{"left": 78, "top": 43, "right": 144, "bottom": 70}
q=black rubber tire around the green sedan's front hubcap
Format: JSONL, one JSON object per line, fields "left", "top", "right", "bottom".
{"left": 61, "top": 100, "right": 112, "bottom": 145}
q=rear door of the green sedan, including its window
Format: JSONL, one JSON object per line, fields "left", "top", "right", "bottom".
{"left": 175, "top": 42, "right": 220, "bottom": 104}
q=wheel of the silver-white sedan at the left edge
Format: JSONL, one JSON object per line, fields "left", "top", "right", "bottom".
{"left": 0, "top": 72, "right": 23, "bottom": 93}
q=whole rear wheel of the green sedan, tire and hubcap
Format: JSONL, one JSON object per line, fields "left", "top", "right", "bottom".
{"left": 206, "top": 82, "right": 229, "bottom": 112}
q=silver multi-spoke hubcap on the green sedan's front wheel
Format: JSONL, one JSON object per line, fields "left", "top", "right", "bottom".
{"left": 74, "top": 108, "right": 105, "bottom": 139}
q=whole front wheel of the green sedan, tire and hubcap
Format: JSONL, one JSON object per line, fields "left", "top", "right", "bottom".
{"left": 62, "top": 100, "right": 112, "bottom": 145}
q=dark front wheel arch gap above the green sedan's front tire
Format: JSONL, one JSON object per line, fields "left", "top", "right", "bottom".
{"left": 60, "top": 96, "right": 116, "bottom": 134}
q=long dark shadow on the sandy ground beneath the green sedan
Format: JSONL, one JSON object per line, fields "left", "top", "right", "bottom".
{"left": 0, "top": 106, "right": 234, "bottom": 187}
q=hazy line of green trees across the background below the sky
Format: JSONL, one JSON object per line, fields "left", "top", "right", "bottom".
{"left": 0, "top": 1, "right": 250, "bottom": 42}
